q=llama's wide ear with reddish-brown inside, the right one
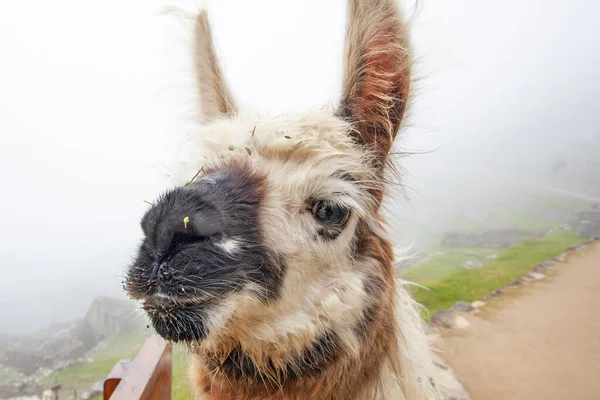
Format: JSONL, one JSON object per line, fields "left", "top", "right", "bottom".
{"left": 339, "top": 0, "right": 411, "bottom": 165}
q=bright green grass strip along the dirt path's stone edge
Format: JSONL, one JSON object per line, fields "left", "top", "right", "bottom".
{"left": 404, "top": 230, "right": 581, "bottom": 319}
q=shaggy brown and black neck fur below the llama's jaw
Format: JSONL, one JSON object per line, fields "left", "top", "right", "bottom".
{"left": 190, "top": 227, "right": 408, "bottom": 400}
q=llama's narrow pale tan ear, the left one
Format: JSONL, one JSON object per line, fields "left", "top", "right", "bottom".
{"left": 194, "top": 10, "right": 236, "bottom": 122}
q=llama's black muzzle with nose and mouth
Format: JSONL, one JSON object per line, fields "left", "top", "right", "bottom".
{"left": 125, "top": 166, "right": 281, "bottom": 341}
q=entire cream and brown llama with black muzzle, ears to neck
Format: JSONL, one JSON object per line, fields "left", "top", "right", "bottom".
{"left": 125, "top": 0, "right": 440, "bottom": 400}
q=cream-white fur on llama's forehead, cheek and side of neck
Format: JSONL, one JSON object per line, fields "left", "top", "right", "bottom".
{"left": 162, "top": 109, "right": 438, "bottom": 399}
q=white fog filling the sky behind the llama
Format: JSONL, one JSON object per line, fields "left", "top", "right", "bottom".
{"left": 0, "top": 0, "right": 600, "bottom": 333}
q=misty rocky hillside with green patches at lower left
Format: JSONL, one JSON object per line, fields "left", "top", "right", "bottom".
{"left": 0, "top": 297, "right": 140, "bottom": 398}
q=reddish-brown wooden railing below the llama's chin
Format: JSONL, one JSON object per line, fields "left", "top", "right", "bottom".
{"left": 104, "top": 336, "right": 172, "bottom": 400}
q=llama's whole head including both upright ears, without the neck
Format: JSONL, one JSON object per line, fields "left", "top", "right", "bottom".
{"left": 125, "top": 0, "right": 410, "bottom": 362}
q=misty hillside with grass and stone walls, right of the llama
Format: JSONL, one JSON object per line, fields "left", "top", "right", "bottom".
{"left": 398, "top": 193, "right": 600, "bottom": 319}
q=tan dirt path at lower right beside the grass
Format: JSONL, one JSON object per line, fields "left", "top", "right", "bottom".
{"left": 436, "top": 244, "right": 600, "bottom": 400}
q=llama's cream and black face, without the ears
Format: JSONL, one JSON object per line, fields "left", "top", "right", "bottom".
{"left": 122, "top": 110, "right": 375, "bottom": 341}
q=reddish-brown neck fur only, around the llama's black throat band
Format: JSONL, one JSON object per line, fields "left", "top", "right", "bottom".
{"left": 190, "top": 220, "right": 397, "bottom": 400}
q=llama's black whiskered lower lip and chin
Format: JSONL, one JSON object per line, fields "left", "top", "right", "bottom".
{"left": 142, "top": 295, "right": 212, "bottom": 342}
